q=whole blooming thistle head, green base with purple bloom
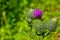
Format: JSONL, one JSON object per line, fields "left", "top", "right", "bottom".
{"left": 26, "top": 9, "right": 42, "bottom": 23}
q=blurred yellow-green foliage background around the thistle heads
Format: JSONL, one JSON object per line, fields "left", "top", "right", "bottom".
{"left": 0, "top": 0, "right": 60, "bottom": 40}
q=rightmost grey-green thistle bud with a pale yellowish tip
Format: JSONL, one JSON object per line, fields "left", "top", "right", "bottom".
{"left": 47, "top": 17, "right": 57, "bottom": 31}
